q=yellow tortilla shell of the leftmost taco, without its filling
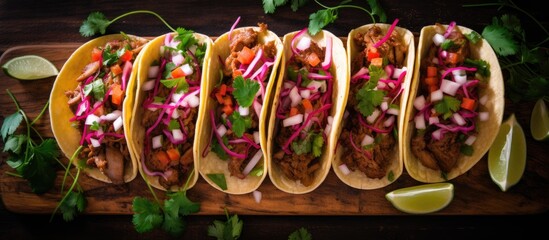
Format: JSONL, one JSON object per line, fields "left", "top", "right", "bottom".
{"left": 49, "top": 34, "right": 148, "bottom": 183}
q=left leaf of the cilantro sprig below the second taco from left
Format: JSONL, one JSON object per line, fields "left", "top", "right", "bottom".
{"left": 132, "top": 197, "right": 164, "bottom": 233}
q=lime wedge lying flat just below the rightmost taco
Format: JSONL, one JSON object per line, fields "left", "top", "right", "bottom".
{"left": 385, "top": 183, "right": 454, "bottom": 214}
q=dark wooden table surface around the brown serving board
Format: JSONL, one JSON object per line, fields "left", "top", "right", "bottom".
{"left": 0, "top": 0, "right": 549, "bottom": 239}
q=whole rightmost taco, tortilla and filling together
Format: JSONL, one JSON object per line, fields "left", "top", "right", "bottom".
{"left": 403, "top": 22, "right": 504, "bottom": 182}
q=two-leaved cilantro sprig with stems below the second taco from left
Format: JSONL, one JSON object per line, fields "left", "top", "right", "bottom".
{"left": 132, "top": 170, "right": 200, "bottom": 236}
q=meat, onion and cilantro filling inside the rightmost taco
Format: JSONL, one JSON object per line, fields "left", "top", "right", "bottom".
{"left": 410, "top": 22, "right": 490, "bottom": 173}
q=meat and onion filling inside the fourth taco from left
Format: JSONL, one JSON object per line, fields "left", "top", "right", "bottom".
{"left": 273, "top": 28, "right": 334, "bottom": 186}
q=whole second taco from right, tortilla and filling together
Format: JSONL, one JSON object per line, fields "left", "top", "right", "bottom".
{"left": 332, "top": 20, "right": 415, "bottom": 189}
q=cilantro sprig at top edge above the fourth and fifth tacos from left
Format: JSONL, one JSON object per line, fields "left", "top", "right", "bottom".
{"left": 263, "top": 0, "right": 387, "bottom": 35}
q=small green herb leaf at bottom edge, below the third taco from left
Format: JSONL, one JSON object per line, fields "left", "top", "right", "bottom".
{"left": 208, "top": 209, "right": 244, "bottom": 240}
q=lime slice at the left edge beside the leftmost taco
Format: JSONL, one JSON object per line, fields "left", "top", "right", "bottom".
{"left": 2, "top": 55, "right": 59, "bottom": 80}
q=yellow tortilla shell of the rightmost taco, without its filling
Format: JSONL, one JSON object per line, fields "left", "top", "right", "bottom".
{"left": 402, "top": 25, "right": 505, "bottom": 183}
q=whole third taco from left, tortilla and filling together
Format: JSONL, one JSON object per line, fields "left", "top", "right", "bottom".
{"left": 198, "top": 23, "right": 282, "bottom": 194}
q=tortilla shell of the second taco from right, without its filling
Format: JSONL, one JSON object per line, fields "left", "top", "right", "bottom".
{"left": 332, "top": 23, "right": 415, "bottom": 189}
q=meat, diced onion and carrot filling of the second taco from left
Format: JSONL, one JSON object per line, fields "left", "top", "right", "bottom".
{"left": 141, "top": 28, "right": 206, "bottom": 189}
